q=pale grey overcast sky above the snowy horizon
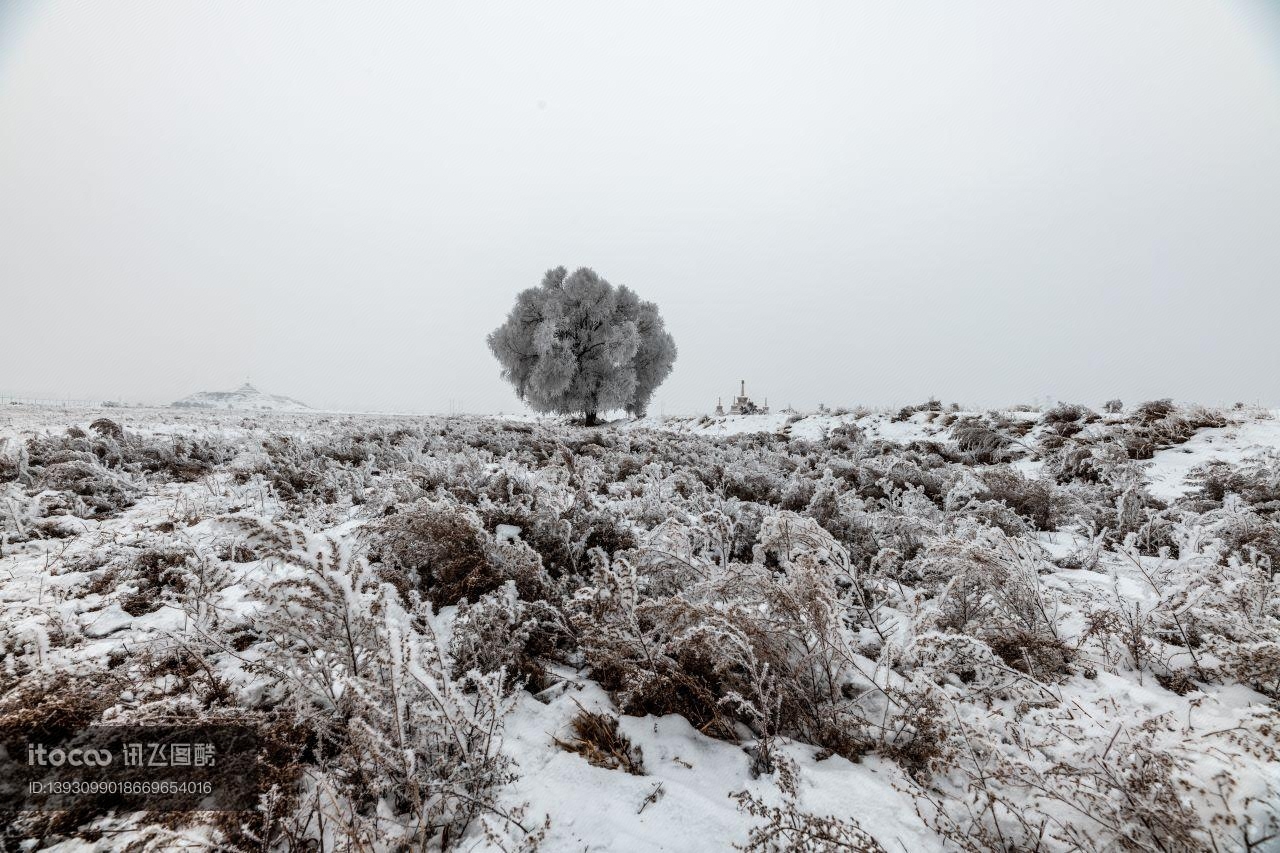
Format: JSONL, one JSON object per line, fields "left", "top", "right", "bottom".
{"left": 0, "top": 0, "right": 1280, "bottom": 414}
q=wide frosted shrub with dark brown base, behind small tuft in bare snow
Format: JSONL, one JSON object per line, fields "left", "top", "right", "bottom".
{"left": 572, "top": 514, "right": 880, "bottom": 763}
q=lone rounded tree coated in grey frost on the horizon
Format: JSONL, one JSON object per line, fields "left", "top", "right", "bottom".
{"left": 489, "top": 266, "right": 676, "bottom": 425}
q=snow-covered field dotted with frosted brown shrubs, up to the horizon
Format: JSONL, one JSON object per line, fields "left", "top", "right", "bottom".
{"left": 0, "top": 406, "right": 1280, "bottom": 852}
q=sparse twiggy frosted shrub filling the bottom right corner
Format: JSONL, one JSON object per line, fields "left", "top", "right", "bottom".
{"left": 914, "top": 707, "right": 1280, "bottom": 853}
